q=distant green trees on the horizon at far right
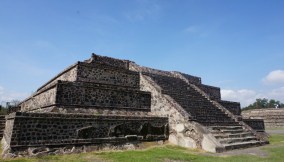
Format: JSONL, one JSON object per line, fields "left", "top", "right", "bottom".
{"left": 242, "top": 98, "right": 284, "bottom": 111}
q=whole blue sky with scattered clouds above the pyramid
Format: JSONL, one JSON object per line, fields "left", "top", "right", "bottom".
{"left": 0, "top": 0, "right": 284, "bottom": 106}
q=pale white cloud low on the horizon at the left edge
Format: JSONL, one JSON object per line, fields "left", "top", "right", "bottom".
{"left": 0, "top": 86, "right": 30, "bottom": 105}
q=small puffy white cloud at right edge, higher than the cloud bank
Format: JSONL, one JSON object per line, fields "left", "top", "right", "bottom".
{"left": 263, "top": 70, "right": 284, "bottom": 84}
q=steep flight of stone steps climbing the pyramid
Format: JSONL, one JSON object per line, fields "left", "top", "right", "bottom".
{"left": 143, "top": 73, "right": 266, "bottom": 150}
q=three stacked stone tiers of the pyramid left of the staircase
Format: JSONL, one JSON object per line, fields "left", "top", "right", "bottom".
{"left": 3, "top": 54, "right": 169, "bottom": 156}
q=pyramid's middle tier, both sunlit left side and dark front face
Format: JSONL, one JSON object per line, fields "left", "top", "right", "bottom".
{"left": 21, "top": 81, "right": 151, "bottom": 111}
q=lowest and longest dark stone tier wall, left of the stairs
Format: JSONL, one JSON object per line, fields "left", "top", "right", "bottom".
{"left": 4, "top": 112, "right": 168, "bottom": 150}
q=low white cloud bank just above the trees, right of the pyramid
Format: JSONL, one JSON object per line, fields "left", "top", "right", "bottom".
{"left": 221, "top": 87, "right": 284, "bottom": 107}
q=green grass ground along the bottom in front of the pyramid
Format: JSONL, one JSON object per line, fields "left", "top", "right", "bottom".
{"left": 2, "top": 135, "right": 284, "bottom": 162}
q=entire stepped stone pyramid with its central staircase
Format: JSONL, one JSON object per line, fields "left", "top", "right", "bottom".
{"left": 2, "top": 54, "right": 267, "bottom": 157}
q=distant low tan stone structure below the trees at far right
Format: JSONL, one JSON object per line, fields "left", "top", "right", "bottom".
{"left": 242, "top": 108, "right": 284, "bottom": 129}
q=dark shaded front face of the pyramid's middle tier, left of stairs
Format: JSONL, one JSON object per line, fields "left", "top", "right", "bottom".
{"left": 56, "top": 82, "right": 151, "bottom": 111}
